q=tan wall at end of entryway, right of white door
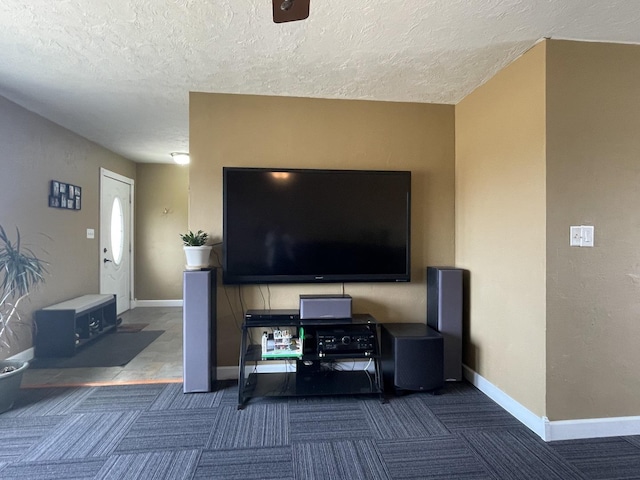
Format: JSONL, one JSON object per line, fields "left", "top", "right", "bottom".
{"left": 135, "top": 163, "right": 189, "bottom": 300}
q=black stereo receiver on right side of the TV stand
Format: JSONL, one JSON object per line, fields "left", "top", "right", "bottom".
{"left": 316, "top": 326, "right": 376, "bottom": 357}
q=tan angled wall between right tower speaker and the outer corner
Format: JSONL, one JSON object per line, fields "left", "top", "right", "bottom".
{"left": 455, "top": 44, "right": 546, "bottom": 415}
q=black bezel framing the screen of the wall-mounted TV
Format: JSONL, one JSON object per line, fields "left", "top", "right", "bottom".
{"left": 222, "top": 167, "right": 411, "bottom": 285}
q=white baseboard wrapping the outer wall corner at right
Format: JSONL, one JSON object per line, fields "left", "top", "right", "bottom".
{"left": 463, "top": 365, "right": 640, "bottom": 442}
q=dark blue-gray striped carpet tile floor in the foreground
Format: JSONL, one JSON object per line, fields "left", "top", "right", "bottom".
{"left": 0, "top": 382, "right": 640, "bottom": 480}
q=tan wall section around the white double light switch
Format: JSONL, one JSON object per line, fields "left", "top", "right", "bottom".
{"left": 547, "top": 41, "right": 640, "bottom": 420}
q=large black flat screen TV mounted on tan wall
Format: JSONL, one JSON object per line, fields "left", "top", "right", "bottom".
{"left": 222, "top": 167, "right": 411, "bottom": 284}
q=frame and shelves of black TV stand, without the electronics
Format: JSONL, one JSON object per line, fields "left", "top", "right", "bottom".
{"left": 238, "top": 314, "right": 384, "bottom": 409}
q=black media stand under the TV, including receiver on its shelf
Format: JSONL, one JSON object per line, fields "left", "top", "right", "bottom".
{"left": 238, "top": 310, "right": 385, "bottom": 409}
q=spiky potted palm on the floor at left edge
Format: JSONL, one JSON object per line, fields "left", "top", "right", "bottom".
{"left": 0, "top": 225, "right": 46, "bottom": 413}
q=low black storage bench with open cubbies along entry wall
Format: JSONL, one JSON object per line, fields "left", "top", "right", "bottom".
{"left": 35, "top": 295, "right": 117, "bottom": 357}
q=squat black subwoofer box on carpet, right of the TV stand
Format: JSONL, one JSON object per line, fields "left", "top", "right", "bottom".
{"left": 381, "top": 323, "right": 444, "bottom": 392}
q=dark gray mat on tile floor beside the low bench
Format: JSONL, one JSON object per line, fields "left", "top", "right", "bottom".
{"left": 29, "top": 330, "right": 164, "bottom": 368}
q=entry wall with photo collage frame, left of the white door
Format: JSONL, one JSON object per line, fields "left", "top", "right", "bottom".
{"left": 0, "top": 97, "right": 135, "bottom": 358}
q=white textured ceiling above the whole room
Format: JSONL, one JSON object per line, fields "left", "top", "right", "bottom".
{"left": 0, "top": 0, "right": 640, "bottom": 163}
